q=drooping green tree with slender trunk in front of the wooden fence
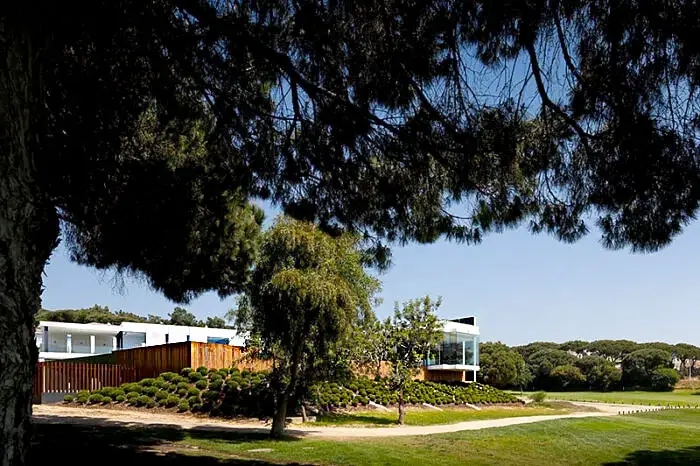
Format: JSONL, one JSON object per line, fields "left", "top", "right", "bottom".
{"left": 236, "top": 217, "right": 379, "bottom": 437}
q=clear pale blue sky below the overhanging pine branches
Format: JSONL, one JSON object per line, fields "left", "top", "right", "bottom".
{"left": 43, "top": 211, "right": 700, "bottom": 345}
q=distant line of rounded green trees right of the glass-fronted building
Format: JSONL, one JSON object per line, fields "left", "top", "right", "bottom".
{"left": 478, "top": 340, "right": 700, "bottom": 391}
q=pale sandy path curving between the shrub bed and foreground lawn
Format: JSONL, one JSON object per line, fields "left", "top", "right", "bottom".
{"left": 33, "top": 402, "right": 658, "bottom": 438}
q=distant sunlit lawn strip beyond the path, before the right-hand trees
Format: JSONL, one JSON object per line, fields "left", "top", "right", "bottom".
{"left": 513, "top": 390, "right": 700, "bottom": 407}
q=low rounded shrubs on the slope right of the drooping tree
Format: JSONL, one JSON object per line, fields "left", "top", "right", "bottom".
{"left": 310, "top": 377, "right": 517, "bottom": 409}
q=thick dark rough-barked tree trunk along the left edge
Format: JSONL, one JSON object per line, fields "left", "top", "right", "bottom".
{"left": 0, "top": 14, "right": 58, "bottom": 466}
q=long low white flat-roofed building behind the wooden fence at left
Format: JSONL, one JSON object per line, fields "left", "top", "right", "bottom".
{"left": 36, "top": 321, "right": 244, "bottom": 361}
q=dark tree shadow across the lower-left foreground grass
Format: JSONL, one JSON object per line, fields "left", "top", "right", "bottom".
{"left": 28, "top": 417, "right": 308, "bottom": 466}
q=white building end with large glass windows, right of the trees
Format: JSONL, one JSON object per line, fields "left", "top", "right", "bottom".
{"left": 425, "top": 317, "right": 479, "bottom": 382}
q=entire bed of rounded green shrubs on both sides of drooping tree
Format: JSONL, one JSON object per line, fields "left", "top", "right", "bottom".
{"left": 65, "top": 367, "right": 518, "bottom": 417}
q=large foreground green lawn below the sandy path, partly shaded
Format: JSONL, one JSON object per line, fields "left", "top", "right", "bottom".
{"left": 32, "top": 409, "right": 700, "bottom": 466}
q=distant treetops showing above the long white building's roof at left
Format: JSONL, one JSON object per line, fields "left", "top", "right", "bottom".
{"left": 36, "top": 304, "right": 231, "bottom": 328}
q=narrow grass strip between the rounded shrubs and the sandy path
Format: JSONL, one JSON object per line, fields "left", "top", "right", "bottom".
{"left": 314, "top": 402, "right": 574, "bottom": 426}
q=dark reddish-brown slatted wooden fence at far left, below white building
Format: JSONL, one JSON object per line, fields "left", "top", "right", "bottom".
{"left": 33, "top": 361, "right": 137, "bottom": 403}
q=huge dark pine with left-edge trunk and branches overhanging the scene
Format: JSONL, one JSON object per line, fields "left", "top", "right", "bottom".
{"left": 6, "top": 0, "right": 700, "bottom": 466}
